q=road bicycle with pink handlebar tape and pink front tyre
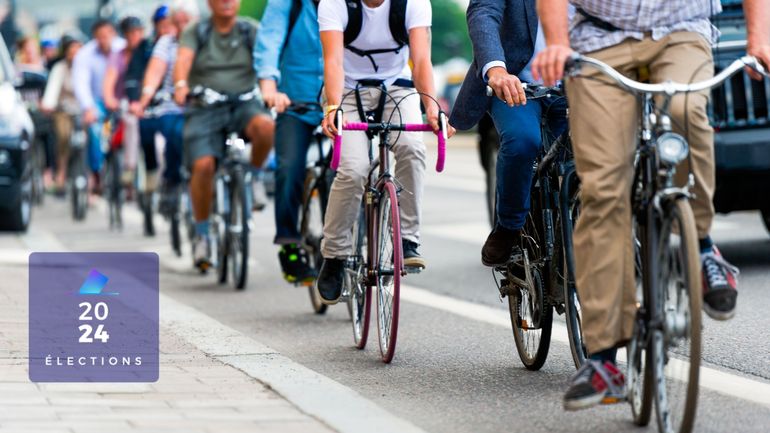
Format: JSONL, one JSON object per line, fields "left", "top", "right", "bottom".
{"left": 331, "top": 89, "right": 447, "bottom": 363}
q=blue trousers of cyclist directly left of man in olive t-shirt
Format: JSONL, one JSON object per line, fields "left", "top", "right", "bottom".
{"left": 139, "top": 114, "right": 184, "bottom": 185}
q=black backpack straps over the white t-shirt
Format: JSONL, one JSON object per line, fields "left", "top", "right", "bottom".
{"left": 344, "top": 0, "right": 409, "bottom": 72}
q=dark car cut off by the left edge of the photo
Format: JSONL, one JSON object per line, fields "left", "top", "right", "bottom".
{"left": 0, "top": 33, "right": 34, "bottom": 231}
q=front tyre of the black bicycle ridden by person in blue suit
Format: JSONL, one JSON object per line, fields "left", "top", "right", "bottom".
{"left": 560, "top": 172, "right": 587, "bottom": 368}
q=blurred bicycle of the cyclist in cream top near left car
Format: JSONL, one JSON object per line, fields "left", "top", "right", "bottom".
{"left": 67, "top": 116, "right": 88, "bottom": 221}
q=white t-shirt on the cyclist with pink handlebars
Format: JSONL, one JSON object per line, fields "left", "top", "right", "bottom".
{"left": 318, "top": 0, "right": 432, "bottom": 88}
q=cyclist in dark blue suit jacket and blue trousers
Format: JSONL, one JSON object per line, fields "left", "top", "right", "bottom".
{"left": 450, "top": 0, "right": 567, "bottom": 266}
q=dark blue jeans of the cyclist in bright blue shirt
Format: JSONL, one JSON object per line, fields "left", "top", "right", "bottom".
{"left": 273, "top": 114, "right": 316, "bottom": 245}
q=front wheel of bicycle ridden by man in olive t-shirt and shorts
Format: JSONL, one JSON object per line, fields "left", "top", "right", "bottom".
{"left": 227, "top": 169, "right": 251, "bottom": 290}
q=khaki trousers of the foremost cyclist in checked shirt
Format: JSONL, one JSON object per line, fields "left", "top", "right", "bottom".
{"left": 567, "top": 32, "right": 714, "bottom": 354}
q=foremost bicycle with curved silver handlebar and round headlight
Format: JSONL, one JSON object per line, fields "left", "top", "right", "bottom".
{"left": 567, "top": 54, "right": 767, "bottom": 433}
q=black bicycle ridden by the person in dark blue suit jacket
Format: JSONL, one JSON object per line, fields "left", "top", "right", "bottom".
{"left": 487, "top": 83, "right": 586, "bottom": 370}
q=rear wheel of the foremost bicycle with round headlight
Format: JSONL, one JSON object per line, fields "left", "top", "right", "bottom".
{"left": 626, "top": 219, "right": 654, "bottom": 427}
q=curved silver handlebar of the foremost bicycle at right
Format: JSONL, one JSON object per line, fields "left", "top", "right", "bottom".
{"left": 566, "top": 53, "right": 768, "bottom": 96}
